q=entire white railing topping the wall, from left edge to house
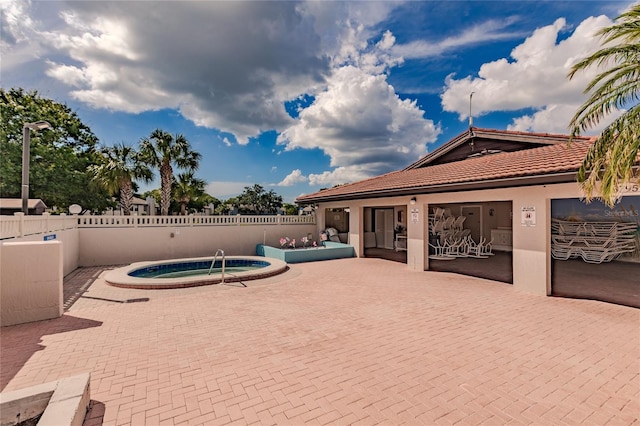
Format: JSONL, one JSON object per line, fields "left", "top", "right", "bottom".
{"left": 0, "top": 213, "right": 316, "bottom": 239}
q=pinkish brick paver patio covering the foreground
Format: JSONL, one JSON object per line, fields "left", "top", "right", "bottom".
{"left": 0, "top": 259, "right": 640, "bottom": 425}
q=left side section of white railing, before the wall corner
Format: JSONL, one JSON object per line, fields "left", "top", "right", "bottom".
{"left": 0, "top": 213, "right": 78, "bottom": 240}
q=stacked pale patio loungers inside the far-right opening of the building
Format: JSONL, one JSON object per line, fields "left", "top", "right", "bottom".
{"left": 551, "top": 219, "right": 637, "bottom": 264}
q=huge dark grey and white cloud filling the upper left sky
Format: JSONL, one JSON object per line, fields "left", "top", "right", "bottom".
{"left": 11, "top": 2, "right": 331, "bottom": 144}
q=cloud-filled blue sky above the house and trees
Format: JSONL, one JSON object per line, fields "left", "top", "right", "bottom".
{"left": 0, "top": 0, "right": 632, "bottom": 202}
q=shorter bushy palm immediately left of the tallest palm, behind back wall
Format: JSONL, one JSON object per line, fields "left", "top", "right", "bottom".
{"left": 88, "top": 144, "right": 153, "bottom": 215}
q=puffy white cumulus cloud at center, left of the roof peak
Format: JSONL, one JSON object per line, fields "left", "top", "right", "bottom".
{"left": 278, "top": 66, "right": 440, "bottom": 180}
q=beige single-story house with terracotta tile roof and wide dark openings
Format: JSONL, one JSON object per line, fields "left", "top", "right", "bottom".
{"left": 296, "top": 127, "right": 640, "bottom": 307}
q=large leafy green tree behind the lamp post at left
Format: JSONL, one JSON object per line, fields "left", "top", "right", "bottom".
{"left": 0, "top": 88, "right": 112, "bottom": 212}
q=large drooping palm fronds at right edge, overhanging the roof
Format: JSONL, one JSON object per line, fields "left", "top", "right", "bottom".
{"left": 569, "top": 5, "right": 640, "bottom": 207}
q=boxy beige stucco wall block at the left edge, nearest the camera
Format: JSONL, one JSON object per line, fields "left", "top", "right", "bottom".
{"left": 0, "top": 241, "right": 63, "bottom": 327}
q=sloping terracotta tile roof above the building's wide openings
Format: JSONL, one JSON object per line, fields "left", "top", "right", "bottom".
{"left": 296, "top": 140, "right": 591, "bottom": 203}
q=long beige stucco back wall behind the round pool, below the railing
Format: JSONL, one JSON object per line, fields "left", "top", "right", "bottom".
{"left": 78, "top": 224, "right": 319, "bottom": 266}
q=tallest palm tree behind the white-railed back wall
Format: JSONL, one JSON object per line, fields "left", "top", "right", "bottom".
{"left": 140, "top": 129, "right": 202, "bottom": 216}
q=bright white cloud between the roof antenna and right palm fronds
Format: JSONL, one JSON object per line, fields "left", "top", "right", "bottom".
{"left": 442, "top": 16, "right": 612, "bottom": 133}
